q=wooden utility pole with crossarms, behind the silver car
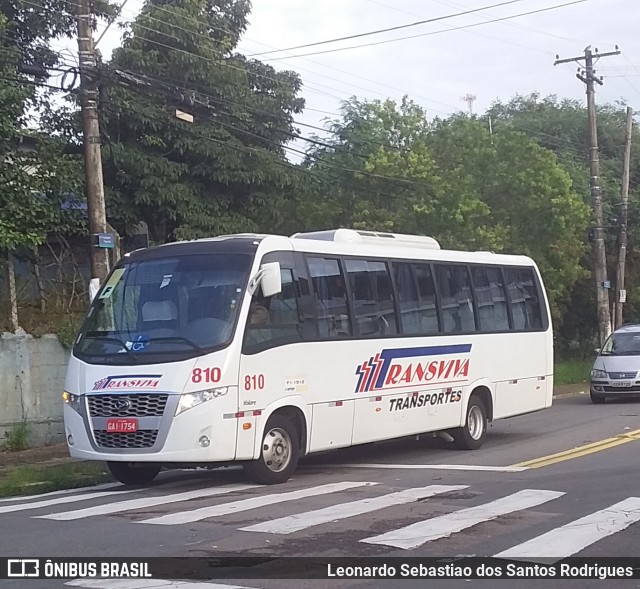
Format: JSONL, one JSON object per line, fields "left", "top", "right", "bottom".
{"left": 553, "top": 45, "right": 620, "bottom": 345}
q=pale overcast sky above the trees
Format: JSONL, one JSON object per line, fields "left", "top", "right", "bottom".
{"left": 53, "top": 0, "right": 640, "bottom": 153}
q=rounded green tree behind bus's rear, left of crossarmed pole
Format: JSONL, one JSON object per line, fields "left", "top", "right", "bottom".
{"left": 431, "top": 116, "right": 589, "bottom": 326}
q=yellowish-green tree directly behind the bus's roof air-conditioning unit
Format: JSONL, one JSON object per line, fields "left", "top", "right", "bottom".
{"left": 298, "top": 98, "right": 497, "bottom": 247}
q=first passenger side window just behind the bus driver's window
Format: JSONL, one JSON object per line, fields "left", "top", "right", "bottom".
{"left": 307, "top": 256, "right": 351, "bottom": 339}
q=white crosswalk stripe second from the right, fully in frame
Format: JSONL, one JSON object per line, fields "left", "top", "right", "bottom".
{"left": 360, "top": 489, "right": 564, "bottom": 549}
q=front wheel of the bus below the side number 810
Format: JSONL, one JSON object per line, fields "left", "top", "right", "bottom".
{"left": 243, "top": 414, "right": 300, "bottom": 485}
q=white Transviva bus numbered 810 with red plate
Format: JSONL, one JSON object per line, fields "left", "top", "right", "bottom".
{"left": 63, "top": 229, "right": 553, "bottom": 484}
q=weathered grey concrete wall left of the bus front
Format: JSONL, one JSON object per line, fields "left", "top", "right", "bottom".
{"left": 0, "top": 333, "right": 69, "bottom": 447}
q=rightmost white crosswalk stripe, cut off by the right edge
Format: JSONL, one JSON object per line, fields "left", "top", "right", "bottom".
{"left": 495, "top": 497, "right": 640, "bottom": 559}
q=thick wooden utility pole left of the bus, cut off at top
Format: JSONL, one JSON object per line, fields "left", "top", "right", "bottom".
{"left": 76, "top": 0, "right": 109, "bottom": 289}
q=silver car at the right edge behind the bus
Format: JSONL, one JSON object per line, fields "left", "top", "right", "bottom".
{"left": 589, "top": 324, "right": 640, "bottom": 404}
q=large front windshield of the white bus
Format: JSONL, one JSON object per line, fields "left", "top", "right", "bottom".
{"left": 73, "top": 254, "right": 251, "bottom": 364}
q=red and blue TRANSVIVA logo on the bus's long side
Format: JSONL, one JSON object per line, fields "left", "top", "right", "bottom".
{"left": 356, "top": 344, "right": 471, "bottom": 393}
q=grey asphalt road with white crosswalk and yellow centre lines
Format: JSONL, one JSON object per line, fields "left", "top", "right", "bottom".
{"left": 0, "top": 395, "right": 640, "bottom": 589}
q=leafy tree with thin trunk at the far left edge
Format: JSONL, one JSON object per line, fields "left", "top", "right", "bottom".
{"left": 0, "top": 0, "right": 92, "bottom": 330}
